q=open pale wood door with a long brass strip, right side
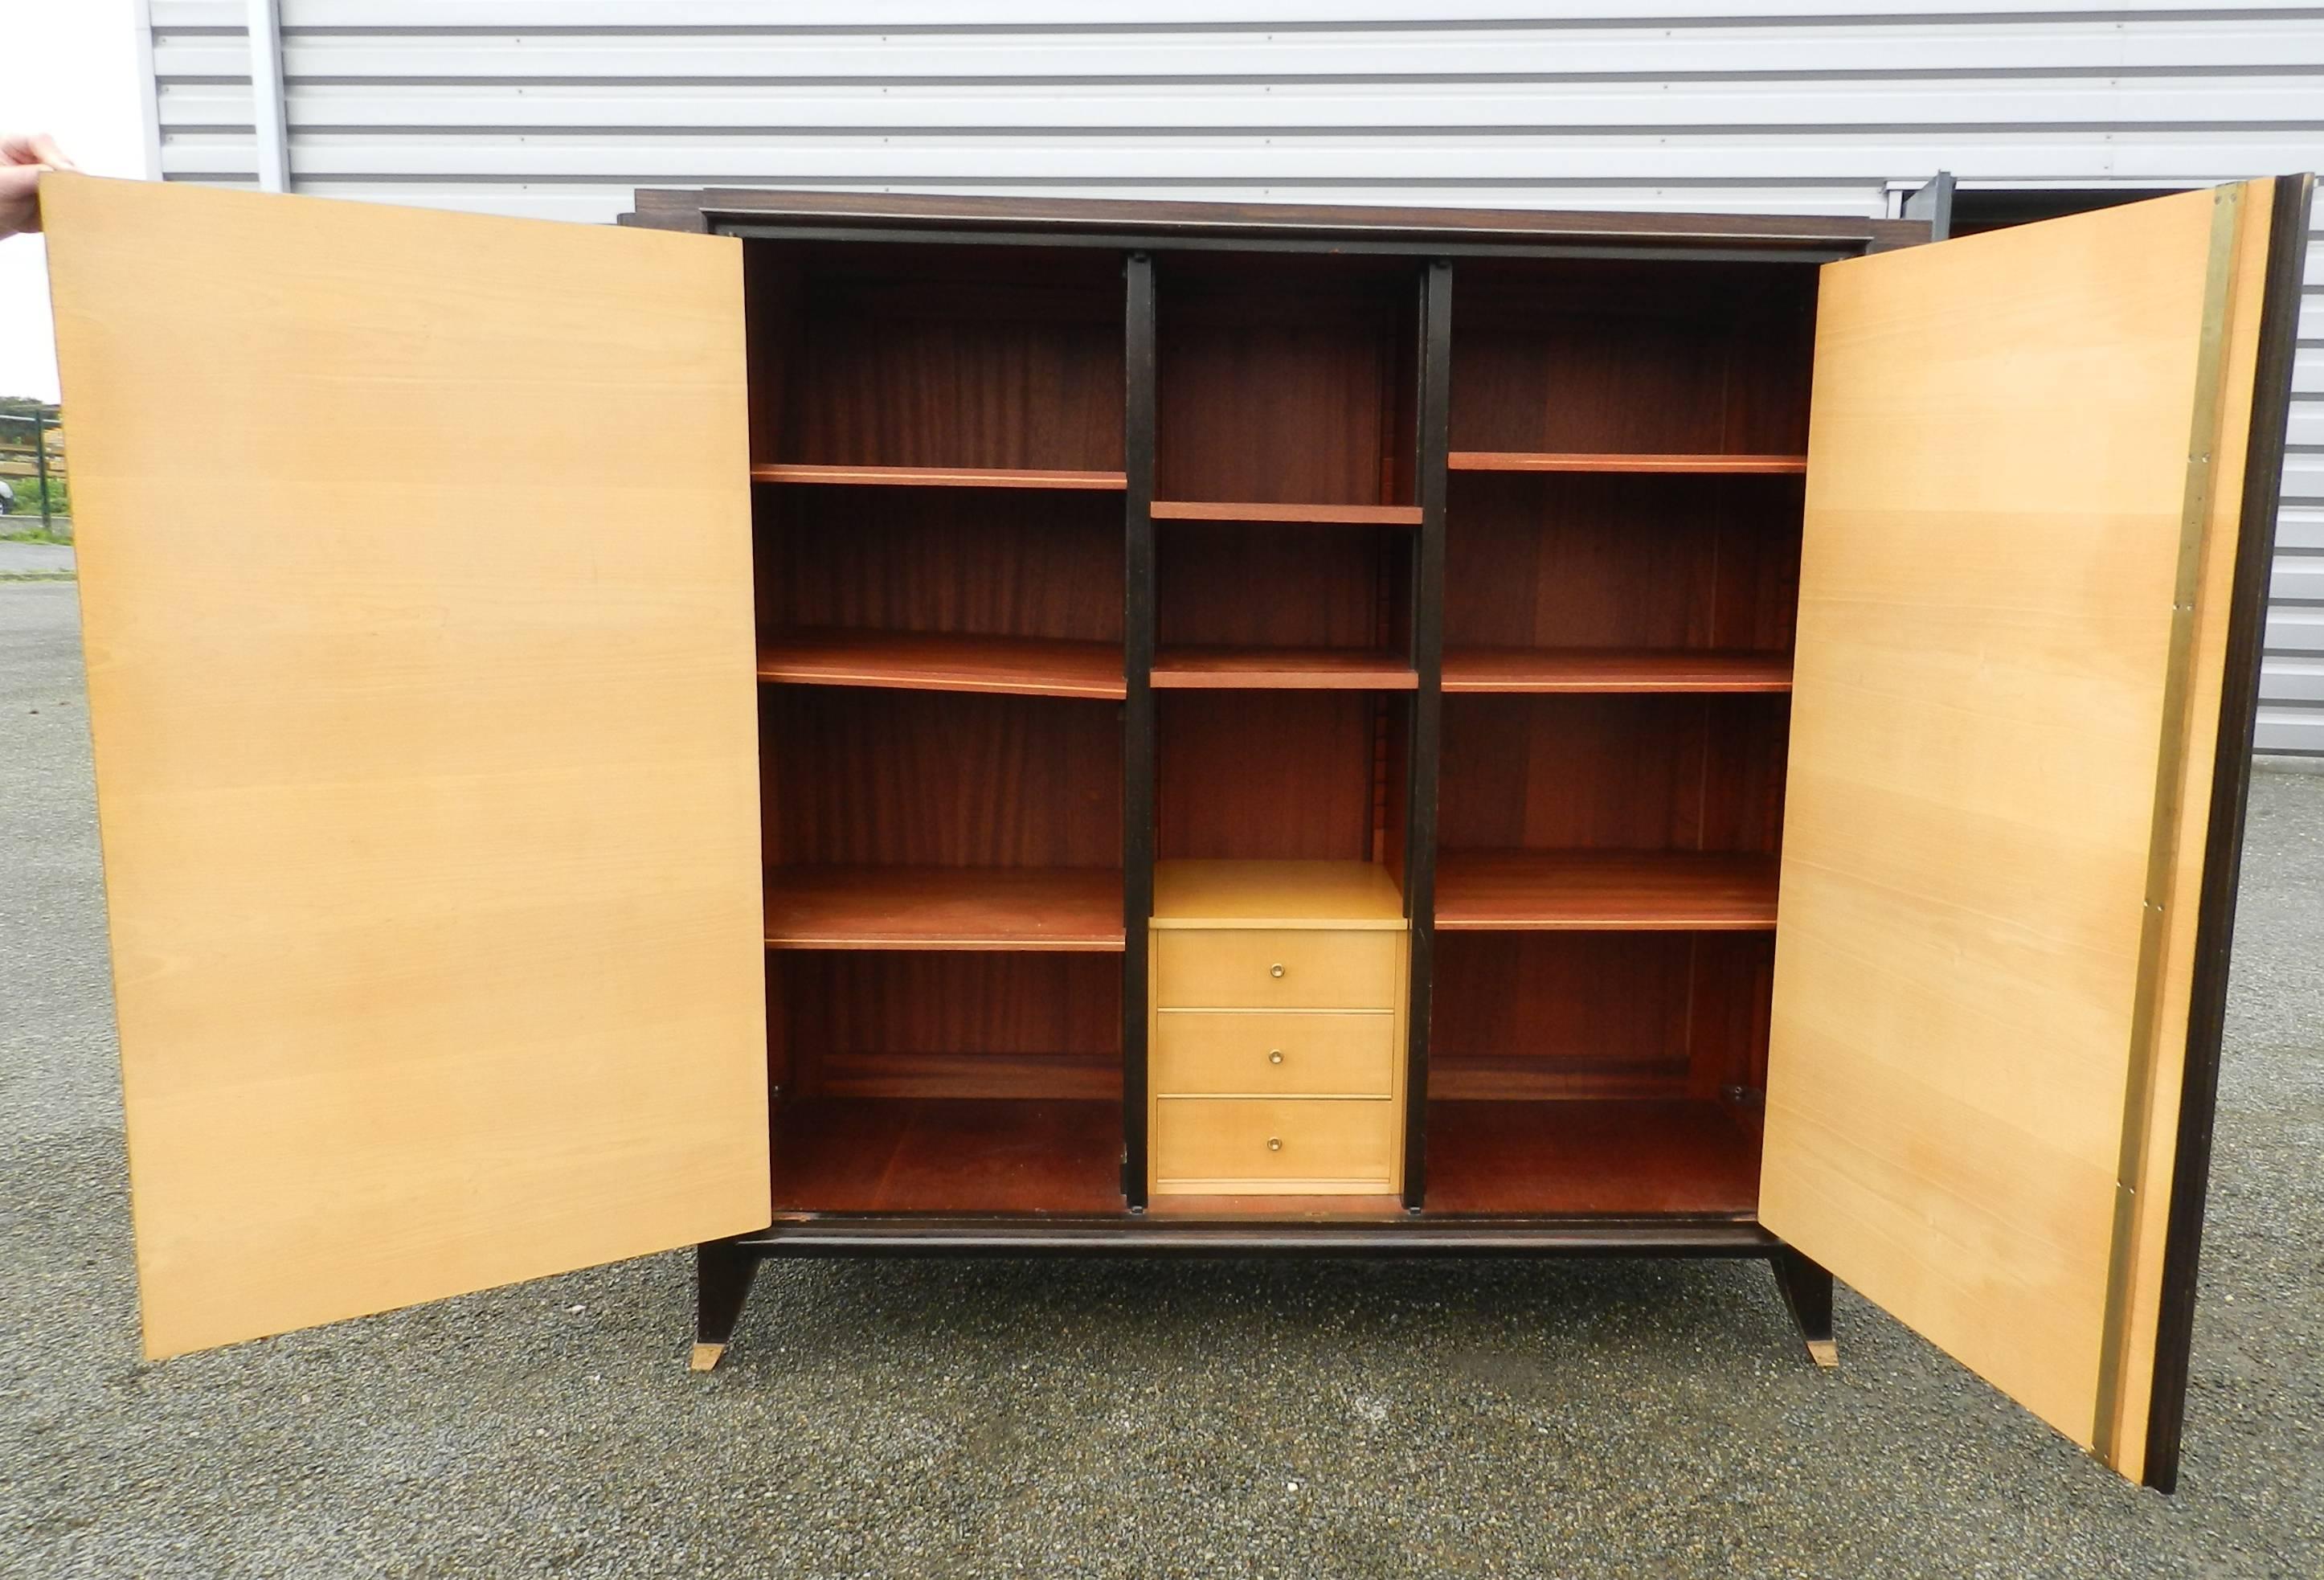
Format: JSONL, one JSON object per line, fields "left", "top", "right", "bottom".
{"left": 1761, "top": 179, "right": 2308, "bottom": 1484}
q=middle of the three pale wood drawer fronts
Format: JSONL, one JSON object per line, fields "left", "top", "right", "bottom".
{"left": 1151, "top": 1009, "right": 1397, "bottom": 1097}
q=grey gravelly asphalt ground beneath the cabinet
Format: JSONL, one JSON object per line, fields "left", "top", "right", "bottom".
{"left": 0, "top": 586, "right": 2324, "bottom": 1580}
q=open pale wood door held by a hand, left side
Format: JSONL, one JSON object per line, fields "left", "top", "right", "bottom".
{"left": 42, "top": 177, "right": 767, "bottom": 1357}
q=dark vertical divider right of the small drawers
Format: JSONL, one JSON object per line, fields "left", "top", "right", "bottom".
{"left": 1404, "top": 258, "right": 1453, "bottom": 1213}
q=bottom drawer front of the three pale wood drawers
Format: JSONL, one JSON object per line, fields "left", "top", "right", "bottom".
{"left": 1152, "top": 1097, "right": 1401, "bottom": 1192}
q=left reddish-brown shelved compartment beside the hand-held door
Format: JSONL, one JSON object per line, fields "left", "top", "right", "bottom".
{"left": 743, "top": 242, "right": 1125, "bottom": 1213}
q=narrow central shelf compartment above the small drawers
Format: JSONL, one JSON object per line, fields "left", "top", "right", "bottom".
{"left": 1152, "top": 253, "right": 1420, "bottom": 876}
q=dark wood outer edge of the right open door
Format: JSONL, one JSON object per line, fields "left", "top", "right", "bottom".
{"left": 2142, "top": 174, "right": 2314, "bottom": 1492}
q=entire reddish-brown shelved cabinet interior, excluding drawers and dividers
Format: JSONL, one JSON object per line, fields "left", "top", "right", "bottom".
{"left": 746, "top": 239, "right": 1815, "bottom": 1215}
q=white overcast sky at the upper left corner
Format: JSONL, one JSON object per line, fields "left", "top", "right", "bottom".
{"left": 0, "top": 0, "right": 144, "bottom": 399}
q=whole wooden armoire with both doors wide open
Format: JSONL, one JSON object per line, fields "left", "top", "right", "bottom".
{"left": 42, "top": 177, "right": 2310, "bottom": 1487}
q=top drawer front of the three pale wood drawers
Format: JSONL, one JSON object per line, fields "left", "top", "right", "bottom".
{"left": 1155, "top": 927, "right": 1404, "bottom": 1009}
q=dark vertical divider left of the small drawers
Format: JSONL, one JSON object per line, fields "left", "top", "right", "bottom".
{"left": 1123, "top": 253, "right": 1160, "bottom": 1213}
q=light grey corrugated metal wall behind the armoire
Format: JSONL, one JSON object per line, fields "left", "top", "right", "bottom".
{"left": 149, "top": 0, "right": 2324, "bottom": 755}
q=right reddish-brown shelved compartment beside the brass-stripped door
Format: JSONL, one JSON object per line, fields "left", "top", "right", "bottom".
{"left": 1425, "top": 260, "right": 1815, "bottom": 1215}
